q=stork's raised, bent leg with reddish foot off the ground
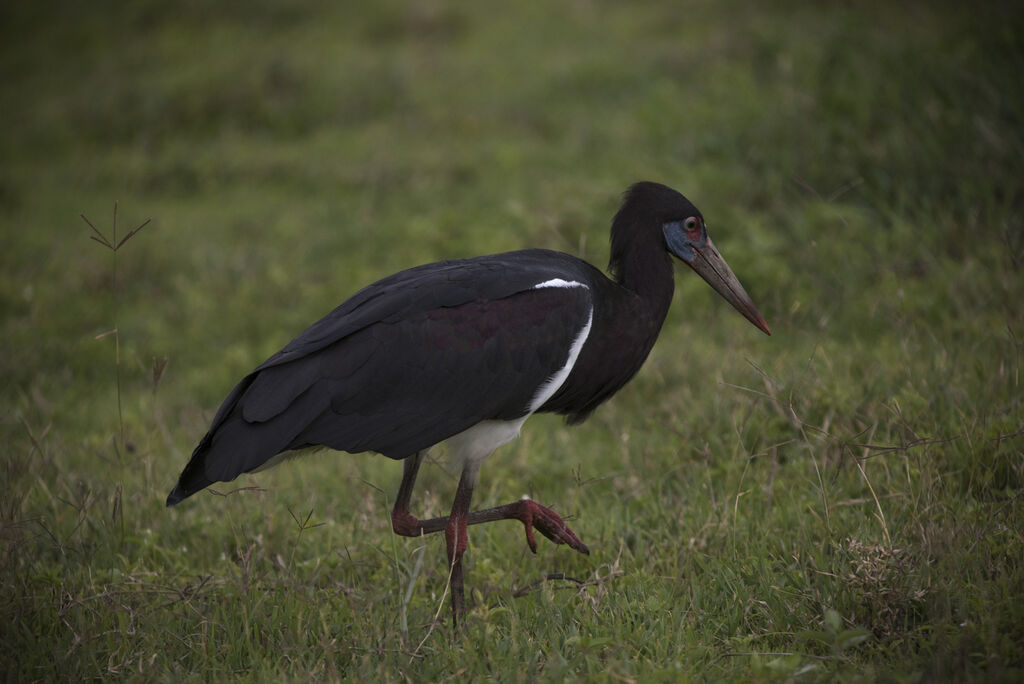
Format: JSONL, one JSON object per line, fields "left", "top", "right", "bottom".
{"left": 391, "top": 453, "right": 590, "bottom": 554}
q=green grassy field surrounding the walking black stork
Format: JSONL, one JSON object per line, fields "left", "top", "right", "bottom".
{"left": 0, "top": 0, "right": 1024, "bottom": 682}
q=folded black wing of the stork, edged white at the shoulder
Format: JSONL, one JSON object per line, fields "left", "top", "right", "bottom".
{"left": 161, "top": 250, "right": 593, "bottom": 505}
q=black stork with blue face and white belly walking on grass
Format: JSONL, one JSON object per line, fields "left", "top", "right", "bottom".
{"left": 167, "top": 182, "right": 770, "bottom": 619}
